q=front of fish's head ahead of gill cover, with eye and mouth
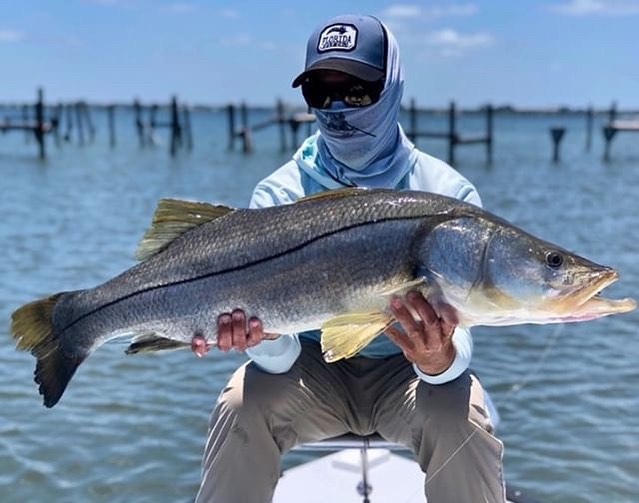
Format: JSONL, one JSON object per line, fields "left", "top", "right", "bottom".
{"left": 470, "top": 222, "right": 636, "bottom": 324}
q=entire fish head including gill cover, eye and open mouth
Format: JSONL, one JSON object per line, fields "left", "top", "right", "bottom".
{"left": 422, "top": 217, "right": 636, "bottom": 326}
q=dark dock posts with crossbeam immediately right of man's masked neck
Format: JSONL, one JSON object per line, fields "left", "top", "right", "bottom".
{"left": 406, "top": 99, "right": 493, "bottom": 165}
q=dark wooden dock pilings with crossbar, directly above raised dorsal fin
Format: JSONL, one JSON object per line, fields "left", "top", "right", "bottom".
{"left": 130, "top": 96, "right": 193, "bottom": 157}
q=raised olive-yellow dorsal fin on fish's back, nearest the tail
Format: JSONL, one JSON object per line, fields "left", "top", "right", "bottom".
{"left": 135, "top": 199, "right": 235, "bottom": 260}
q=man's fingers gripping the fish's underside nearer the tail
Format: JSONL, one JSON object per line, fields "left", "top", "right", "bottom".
{"left": 191, "top": 309, "right": 279, "bottom": 356}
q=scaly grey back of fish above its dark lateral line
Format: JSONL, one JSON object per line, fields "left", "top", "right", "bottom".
{"left": 56, "top": 190, "right": 475, "bottom": 329}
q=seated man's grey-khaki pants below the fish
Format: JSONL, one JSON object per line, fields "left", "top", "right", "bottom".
{"left": 196, "top": 341, "right": 506, "bottom": 503}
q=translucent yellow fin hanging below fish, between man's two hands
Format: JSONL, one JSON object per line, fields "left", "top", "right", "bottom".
{"left": 320, "top": 312, "right": 394, "bottom": 362}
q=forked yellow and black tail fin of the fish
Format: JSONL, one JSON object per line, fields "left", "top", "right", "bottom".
{"left": 11, "top": 292, "right": 88, "bottom": 408}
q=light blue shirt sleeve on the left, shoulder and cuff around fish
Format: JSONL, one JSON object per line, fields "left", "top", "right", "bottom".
{"left": 246, "top": 169, "right": 302, "bottom": 374}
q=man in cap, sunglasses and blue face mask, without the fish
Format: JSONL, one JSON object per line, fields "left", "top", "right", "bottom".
{"left": 194, "top": 15, "right": 505, "bottom": 503}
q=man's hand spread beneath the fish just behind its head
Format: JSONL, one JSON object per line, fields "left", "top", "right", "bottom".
{"left": 386, "top": 291, "right": 458, "bottom": 375}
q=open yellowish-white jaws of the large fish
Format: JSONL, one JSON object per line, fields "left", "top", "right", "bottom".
{"left": 558, "top": 267, "right": 637, "bottom": 322}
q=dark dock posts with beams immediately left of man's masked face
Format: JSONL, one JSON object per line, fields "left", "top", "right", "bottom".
{"left": 226, "top": 100, "right": 315, "bottom": 154}
